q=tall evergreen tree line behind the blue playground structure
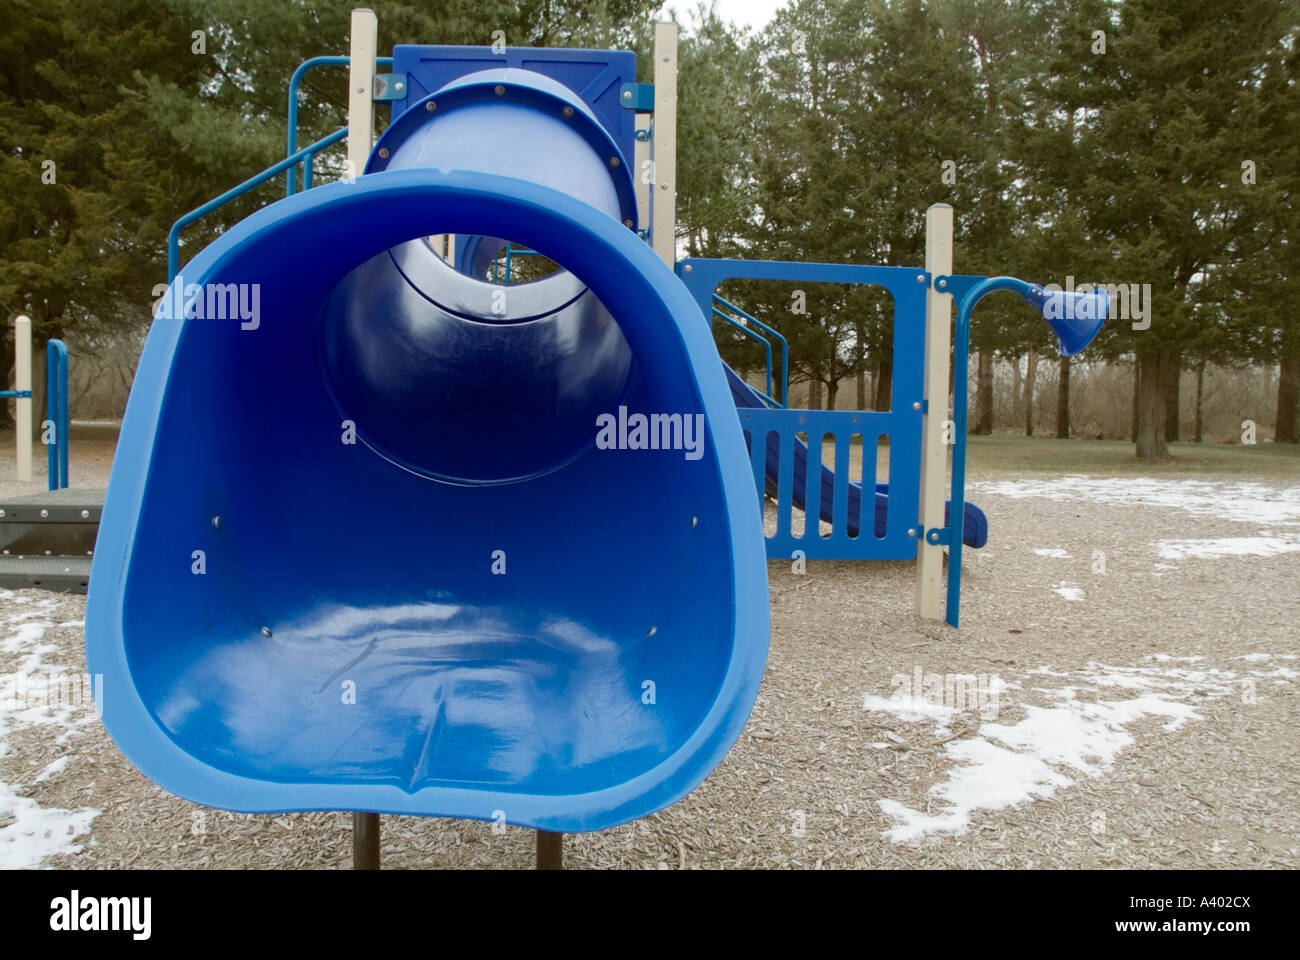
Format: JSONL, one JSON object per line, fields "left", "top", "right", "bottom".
{"left": 0, "top": 0, "right": 1300, "bottom": 457}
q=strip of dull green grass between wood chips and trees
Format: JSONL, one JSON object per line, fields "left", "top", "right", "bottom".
{"left": 822, "top": 433, "right": 1300, "bottom": 480}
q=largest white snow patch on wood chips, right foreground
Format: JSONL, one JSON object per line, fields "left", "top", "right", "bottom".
{"left": 863, "top": 654, "right": 1300, "bottom": 843}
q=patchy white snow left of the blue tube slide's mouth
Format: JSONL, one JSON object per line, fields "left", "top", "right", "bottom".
{"left": 0, "top": 589, "right": 100, "bottom": 870}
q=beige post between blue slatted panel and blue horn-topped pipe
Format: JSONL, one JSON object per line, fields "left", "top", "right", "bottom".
{"left": 917, "top": 203, "right": 962, "bottom": 619}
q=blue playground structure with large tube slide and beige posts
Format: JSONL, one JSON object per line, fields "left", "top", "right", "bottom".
{"left": 86, "top": 10, "right": 1104, "bottom": 866}
